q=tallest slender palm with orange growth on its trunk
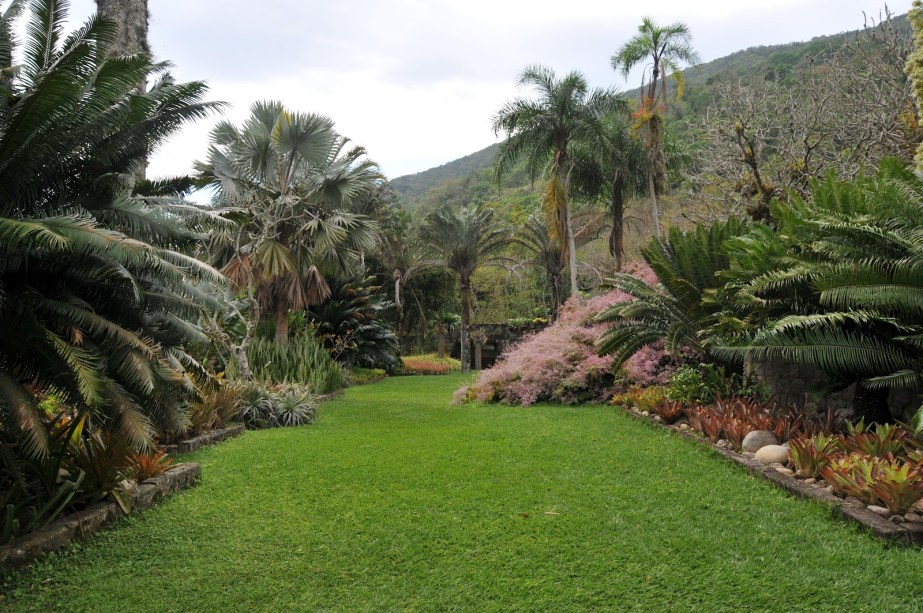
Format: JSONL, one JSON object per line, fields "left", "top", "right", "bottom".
{"left": 611, "top": 17, "right": 701, "bottom": 236}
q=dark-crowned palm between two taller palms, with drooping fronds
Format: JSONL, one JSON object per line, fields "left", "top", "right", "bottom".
{"left": 573, "top": 113, "right": 647, "bottom": 270}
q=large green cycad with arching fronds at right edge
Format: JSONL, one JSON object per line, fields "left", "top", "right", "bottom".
{"left": 717, "top": 160, "right": 923, "bottom": 421}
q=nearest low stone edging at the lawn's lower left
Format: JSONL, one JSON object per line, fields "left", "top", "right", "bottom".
{"left": 0, "top": 463, "right": 201, "bottom": 574}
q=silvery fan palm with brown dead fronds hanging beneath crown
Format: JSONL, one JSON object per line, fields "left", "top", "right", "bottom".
{"left": 196, "top": 102, "right": 381, "bottom": 343}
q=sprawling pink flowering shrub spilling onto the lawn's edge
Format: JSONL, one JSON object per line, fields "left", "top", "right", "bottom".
{"left": 455, "top": 264, "right": 672, "bottom": 406}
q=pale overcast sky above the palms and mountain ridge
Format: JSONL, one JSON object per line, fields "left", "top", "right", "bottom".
{"left": 65, "top": 0, "right": 910, "bottom": 178}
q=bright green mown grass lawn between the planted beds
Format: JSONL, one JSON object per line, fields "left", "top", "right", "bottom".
{"left": 0, "top": 375, "right": 923, "bottom": 611}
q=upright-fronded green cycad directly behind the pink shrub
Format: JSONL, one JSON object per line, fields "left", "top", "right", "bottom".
{"left": 597, "top": 218, "right": 747, "bottom": 366}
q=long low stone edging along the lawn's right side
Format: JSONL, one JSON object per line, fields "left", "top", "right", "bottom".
{"left": 621, "top": 407, "right": 923, "bottom": 547}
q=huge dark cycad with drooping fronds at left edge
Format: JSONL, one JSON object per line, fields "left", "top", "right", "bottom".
{"left": 0, "top": 0, "right": 222, "bottom": 455}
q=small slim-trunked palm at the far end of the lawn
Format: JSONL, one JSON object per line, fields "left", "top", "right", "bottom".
{"left": 420, "top": 205, "right": 510, "bottom": 373}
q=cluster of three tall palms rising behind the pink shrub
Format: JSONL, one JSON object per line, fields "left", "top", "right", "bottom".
{"left": 494, "top": 18, "right": 698, "bottom": 304}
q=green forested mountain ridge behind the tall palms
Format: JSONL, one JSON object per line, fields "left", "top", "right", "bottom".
{"left": 391, "top": 15, "right": 910, "bottom": 211}
